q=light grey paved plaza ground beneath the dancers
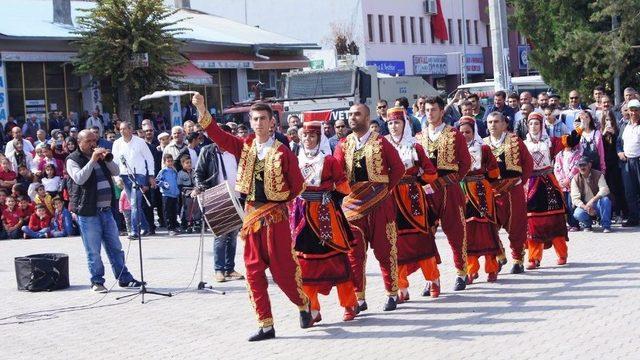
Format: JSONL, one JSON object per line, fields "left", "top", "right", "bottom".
{"left": 0, "top": 228, "right": 640, "bottom": 359}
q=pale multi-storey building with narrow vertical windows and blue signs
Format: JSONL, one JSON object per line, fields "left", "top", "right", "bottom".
{"left": 191, "top": 0, "right": 531, "bottom": 91}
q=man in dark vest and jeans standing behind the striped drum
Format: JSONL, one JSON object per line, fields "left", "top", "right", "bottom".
{"left": 192, "top": 128, "right": 244, "bottom": 282}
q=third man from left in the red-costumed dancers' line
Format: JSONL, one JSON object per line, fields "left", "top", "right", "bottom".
{"left": 416, "top": 97, "right": 471, "bottom": 296}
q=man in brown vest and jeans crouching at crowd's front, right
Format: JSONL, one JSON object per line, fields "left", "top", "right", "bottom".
{"left": 571, "top": 156, "right": 611, "bottom": 233}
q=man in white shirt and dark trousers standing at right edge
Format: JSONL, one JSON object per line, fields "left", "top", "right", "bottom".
{"left": 617, "top": 99, "right": 640, "bottom": 227}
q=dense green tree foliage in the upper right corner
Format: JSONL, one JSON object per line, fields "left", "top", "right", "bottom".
{"left": 508, "top": 0, "right": 640, "bottom": 100}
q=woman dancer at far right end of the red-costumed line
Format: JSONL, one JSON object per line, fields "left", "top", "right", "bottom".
{"left": 524, "top": 112, "right": 568, "bottom": 270}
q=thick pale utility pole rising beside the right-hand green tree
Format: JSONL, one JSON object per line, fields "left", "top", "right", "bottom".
{"left": 489, "top": 0, "right": 511, "bottom": 91}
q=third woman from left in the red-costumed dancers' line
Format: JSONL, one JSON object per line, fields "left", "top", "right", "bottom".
{"left": 458, "top": 116, "right": 502, "bottom": 285}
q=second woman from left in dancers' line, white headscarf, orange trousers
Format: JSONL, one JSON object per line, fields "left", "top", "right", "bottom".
{"left": 385, "top": 107, "right": 440, "bottom": 303}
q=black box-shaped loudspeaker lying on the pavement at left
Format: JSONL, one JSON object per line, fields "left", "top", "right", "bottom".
{"left": 15, "top": 254, "right": 69, "bottom": 292}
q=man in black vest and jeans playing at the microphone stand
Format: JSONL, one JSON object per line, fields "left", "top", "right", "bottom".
{"left": 67, "top": 130, "right": 142, "bottom": 293}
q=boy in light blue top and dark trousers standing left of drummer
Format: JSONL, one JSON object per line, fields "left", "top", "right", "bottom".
{"left": 156, "top": 154, "right": 180, "bottom": 236}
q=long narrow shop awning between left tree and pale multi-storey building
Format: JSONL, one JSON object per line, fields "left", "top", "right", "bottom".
{"left": 187, "top": 52, "right": 309, "bottom": 70}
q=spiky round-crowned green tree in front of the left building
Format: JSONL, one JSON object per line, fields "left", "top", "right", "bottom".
{"left": 75, "top": 0, "right": 185, "bottom": 121}
